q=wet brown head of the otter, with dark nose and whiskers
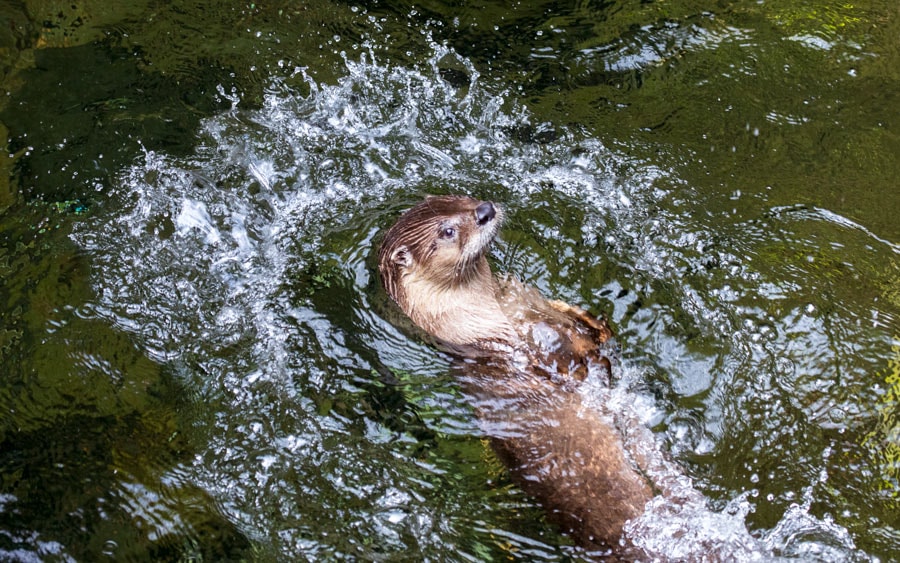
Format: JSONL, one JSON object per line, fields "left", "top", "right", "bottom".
{"left": 378, "top": 196, "right": 502, "bottom": 322}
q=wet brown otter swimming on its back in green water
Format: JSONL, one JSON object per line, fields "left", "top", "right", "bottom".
{"left": 378, "top": 196, "right": 653, "bottom": 553}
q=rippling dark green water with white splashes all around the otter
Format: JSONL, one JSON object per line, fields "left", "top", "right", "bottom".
{"left": 0, "top": 1, "right": 900, "bottom": 561}
